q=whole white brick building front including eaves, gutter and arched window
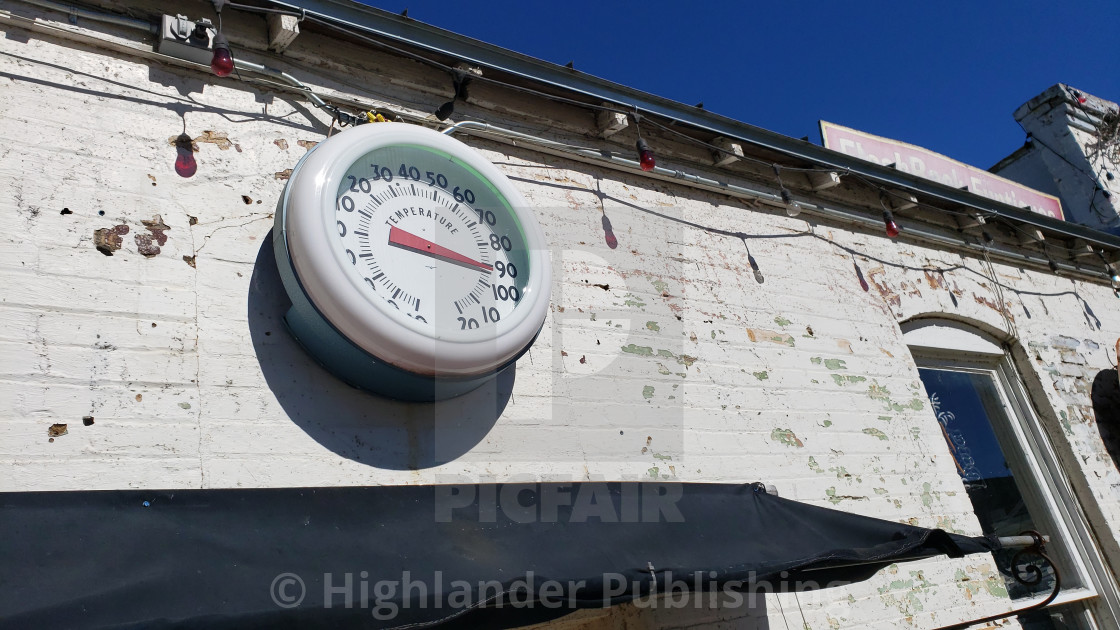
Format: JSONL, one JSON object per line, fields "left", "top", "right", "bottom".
{"left": 0, "top": 0, "right": 1120, "bottom": 629}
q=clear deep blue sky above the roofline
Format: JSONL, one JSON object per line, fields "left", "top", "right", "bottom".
{"left": 366, "top": 0, "right": 1120, "bottom": 168}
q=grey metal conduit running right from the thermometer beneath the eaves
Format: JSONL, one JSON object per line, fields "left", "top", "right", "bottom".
{"left": 442, "top": 120, "right": 1108, "bottom": 279}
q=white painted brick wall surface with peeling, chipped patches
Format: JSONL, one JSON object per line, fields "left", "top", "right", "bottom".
{"left": 0, "top": 11, "right": 1120, "bottom": 628}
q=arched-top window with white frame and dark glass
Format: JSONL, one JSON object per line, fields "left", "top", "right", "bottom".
{"left": 903, "top": 318, "right": 1120, "bottom": 630}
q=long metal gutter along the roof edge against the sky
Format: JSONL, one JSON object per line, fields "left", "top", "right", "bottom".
{"left": 270, "top": 0, "right": 1120, "bottom": 249}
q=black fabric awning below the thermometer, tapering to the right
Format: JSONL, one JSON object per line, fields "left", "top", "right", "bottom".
{"left": 0, "top": 482, "right": 998, "bottom": 628}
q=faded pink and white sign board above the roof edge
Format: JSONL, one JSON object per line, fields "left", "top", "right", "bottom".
{"left": 821, "top": 120, "right": 1065, "bottom": 220}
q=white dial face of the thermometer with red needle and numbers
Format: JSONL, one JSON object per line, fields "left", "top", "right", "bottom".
{"left": 327, "top": 145, "right": 531, "bottom": 341}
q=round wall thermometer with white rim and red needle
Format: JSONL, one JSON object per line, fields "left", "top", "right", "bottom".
{"left": 273, "top": 122, "right": 551, "bottom": 400}
